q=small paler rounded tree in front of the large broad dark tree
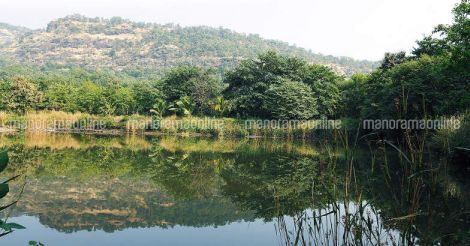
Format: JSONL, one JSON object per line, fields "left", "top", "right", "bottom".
{"left": 266, "top": 80, "right": 318, "bottom": 120}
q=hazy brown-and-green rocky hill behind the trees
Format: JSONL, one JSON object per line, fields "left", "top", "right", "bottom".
{"left": 0, "top": 15, "right": 376, "bottom": 75}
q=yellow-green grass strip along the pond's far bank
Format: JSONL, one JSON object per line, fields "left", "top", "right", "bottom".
{"left": 0, "top": 111, "right": 346, "bottom": 139}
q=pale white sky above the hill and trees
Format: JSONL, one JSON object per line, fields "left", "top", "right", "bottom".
{"left": 0, "top": 0, "right": 459, "bottom": 60}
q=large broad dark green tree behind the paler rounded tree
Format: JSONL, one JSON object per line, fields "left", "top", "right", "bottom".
{"left": 225, "top": 52, "right": 340, "bottom": 117}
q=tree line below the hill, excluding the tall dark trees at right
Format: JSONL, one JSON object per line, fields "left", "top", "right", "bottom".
{"left": 0, "top": 52, "right": 342, "bottom": 119}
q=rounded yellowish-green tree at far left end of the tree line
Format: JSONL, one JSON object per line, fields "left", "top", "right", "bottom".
{"left": 3, "top": 76, "right": 43, "bottom": 114}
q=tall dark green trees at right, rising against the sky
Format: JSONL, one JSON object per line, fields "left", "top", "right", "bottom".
{"left": 341, "top": 0, "right": 470, "bottom": 119}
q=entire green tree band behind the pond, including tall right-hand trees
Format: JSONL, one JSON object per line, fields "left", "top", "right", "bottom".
{"left": 0, "top": 0, "right": 470, "bottom": 122}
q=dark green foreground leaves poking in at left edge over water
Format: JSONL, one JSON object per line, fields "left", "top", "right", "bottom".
{"left": 0, "top": 150, "right": 25, "bottom": 237}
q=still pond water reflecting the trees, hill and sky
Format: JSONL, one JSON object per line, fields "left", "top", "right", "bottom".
{"left": 0, "top": 133, "right": 470, "bottom": 245}
